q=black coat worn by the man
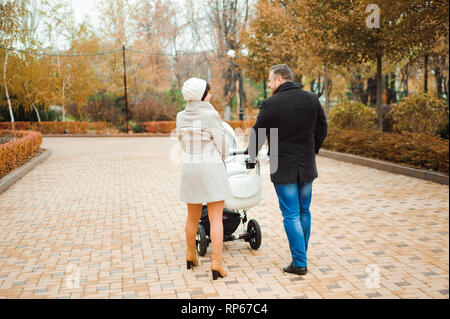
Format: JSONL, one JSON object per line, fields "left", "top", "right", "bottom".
{"left": 246, "top": 82, "right": 327, "bottom": 184}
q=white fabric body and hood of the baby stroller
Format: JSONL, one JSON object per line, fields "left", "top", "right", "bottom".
{"left": 223, "top": 122, "right": 261, "bottom": 210}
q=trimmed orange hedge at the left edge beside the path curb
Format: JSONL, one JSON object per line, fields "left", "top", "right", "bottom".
{"left": 0, "top": 130, "right": 42, "bottom": 178}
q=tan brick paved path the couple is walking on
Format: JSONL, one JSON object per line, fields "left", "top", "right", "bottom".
{"left": 0, "top": 137, "right": 449, "bottom": 298}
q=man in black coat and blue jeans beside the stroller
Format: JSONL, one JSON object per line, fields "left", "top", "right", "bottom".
{"left": 246, "top": 64, "right": 327, "bottom": 275}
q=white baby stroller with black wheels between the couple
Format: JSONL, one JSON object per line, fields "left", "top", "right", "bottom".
{"left": 196, "top": 122, "right": 262, "bottom": 256}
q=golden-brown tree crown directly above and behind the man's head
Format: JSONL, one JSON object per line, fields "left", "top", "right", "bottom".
{"left": 241, "top": 0, "right": 330, "bottom": 104}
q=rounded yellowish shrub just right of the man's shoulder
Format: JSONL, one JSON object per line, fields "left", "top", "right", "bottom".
{"left": 330, "top": 101, "right": 377, "bottom": 129}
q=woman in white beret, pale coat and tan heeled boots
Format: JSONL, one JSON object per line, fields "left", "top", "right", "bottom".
{"left": 177, "top": 78, "right": 232, "bottom": 280}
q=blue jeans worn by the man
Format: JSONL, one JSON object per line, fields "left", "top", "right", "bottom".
{"left": 273, "top": 181, "right": 312, "bottom": 267}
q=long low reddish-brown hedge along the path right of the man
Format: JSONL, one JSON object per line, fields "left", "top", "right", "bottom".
{"left": 324, "top": 128, "right": 449, "bottom": 174}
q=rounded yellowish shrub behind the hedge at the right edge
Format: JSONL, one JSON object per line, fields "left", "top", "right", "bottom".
{"left": 393, "top": 93, "right": 448, "bottom": 135}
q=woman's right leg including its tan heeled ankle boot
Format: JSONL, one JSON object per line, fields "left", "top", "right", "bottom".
{"left": 207, "top": 201, "right": 227, "bottom": 279}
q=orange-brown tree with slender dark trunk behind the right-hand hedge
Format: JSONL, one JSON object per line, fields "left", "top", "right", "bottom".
{"left": 314, "top": 0, "right": 448, "bottom": 130}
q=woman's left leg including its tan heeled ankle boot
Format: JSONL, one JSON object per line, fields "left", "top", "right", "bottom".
{"left": 185, "top": 204, "right": 202, "bottom": 269}
